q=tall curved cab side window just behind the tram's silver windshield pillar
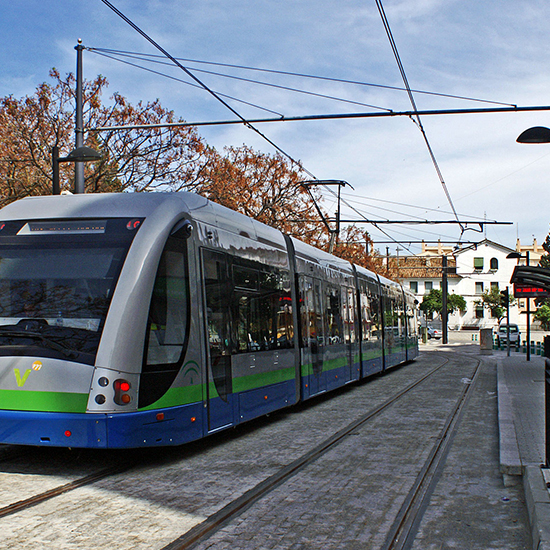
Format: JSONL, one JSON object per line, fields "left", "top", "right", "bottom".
{"left": 143, "top": 237, "right": 189, "bottom": 372}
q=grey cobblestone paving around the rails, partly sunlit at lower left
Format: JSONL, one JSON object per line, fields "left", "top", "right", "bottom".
{"left": 0, "top": 347, "right": 527, "bottom": 550}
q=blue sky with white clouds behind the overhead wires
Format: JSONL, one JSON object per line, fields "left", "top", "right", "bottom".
{"left": 0, "top": 0, "right": 550, "bottom": 255}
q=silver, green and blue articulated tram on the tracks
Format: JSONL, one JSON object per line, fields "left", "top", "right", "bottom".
{"left": 0, "top": 193, "right": 418, "bottom": 448}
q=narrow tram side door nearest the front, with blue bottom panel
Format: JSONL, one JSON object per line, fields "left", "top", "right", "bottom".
{"left": 202, "top": 249, "right": 234, "bottom": 431}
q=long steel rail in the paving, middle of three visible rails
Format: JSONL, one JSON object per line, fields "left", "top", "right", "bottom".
{"left": 161, "top": 359, "right": 449, "bottom": 550}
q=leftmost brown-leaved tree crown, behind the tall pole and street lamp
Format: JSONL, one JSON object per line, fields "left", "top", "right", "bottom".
{"left": 0, "top": 69, "right": 207, "bottom": 206}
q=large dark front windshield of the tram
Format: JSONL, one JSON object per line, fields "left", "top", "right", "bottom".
{"left": 0, "top": 219, "right": 141, "bottom": 364}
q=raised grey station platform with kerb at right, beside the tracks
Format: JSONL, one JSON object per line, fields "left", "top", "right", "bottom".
{"left": 500, "top": 351, "right": 550, "bottom": 550}
